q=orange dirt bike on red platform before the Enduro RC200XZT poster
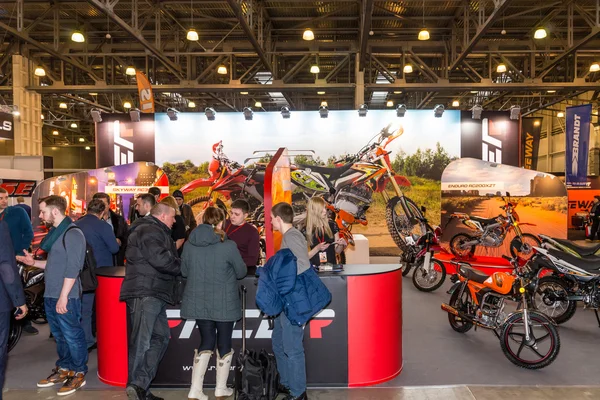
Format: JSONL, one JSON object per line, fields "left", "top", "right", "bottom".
{"left": 446, "top": 192, "right": 541, "bottom": 258}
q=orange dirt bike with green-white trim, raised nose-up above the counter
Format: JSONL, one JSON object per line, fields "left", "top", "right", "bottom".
{"left": 291, "top": 125, "right": 426, "bottom": 249}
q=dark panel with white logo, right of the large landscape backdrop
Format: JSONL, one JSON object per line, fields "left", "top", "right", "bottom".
{"left": 460, "top": 111, "right": 520, "bottom": 167}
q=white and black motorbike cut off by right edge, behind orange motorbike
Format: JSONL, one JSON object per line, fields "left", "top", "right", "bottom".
{"left": 533, "top": 243, "right": 600, "bottom": 326}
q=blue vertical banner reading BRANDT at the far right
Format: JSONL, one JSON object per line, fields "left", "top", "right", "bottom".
{"left": 565, "top": 104, "right": 592, "bottom": 186}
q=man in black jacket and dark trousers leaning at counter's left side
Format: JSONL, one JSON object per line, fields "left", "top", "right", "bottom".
{"left": 121, "top": 203, "right": 181, "bottom": 400}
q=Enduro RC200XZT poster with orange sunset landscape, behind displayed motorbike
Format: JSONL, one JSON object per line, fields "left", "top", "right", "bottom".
{"left": 442, "top": 158, "right": 567, "bottom": 257}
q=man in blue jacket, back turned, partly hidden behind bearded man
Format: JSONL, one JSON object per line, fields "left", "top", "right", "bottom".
{"left": 75, "top": 199, "right": 119, "bottom": 352}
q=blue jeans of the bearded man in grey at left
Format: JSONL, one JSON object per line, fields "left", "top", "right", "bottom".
{"left": 44, "top": 297, "right": 88, "bottom": 373}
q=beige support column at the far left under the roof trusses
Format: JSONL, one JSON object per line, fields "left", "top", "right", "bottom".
{"left": 12, "top": 55, "right": 43, "bottom": 156}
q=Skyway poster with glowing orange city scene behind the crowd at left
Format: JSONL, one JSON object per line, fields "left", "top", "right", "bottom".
{"left": 31, "top": 162, "right": 169, "bottom": 246}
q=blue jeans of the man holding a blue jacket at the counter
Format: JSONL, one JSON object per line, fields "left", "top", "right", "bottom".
{"left": 272, "top": 313, "right": 306, "bottom": 397}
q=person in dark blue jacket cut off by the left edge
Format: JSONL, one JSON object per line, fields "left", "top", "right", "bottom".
{"left": 0, "top": 222, "right": 27, "bottom": 399}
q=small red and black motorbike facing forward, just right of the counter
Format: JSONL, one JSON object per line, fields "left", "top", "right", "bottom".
{"left": 400, "top": 206, "right": 448, "bottom": 292}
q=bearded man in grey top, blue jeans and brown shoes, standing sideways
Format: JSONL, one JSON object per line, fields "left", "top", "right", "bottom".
{"left": 17, "top": 196, "right": 88, "bottom": 396}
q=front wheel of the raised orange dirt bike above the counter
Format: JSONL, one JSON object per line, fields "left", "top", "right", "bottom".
{"left": 385, "top": 196, "right": 427, "bottom": 250}
